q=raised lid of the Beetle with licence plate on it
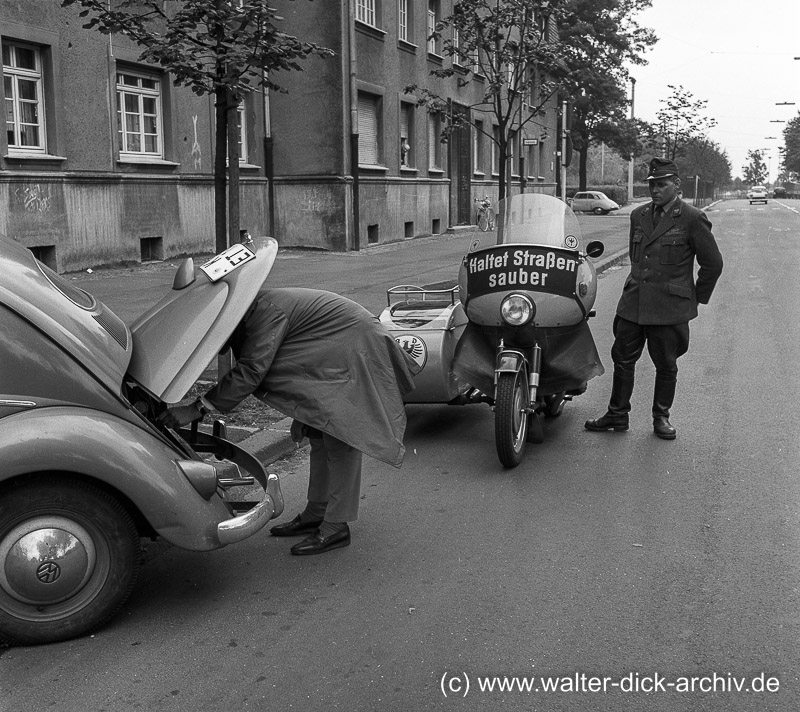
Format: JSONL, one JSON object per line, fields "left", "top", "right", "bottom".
{"left": 128, "top": 237, "right": 278, "bottom": 403}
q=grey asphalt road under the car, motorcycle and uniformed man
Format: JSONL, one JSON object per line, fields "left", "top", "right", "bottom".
{"left": 0, "top": 201, "right": 800, "bottom": 712}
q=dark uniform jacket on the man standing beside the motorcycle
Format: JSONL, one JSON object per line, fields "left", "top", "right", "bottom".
{"left": 617, "top": 198, "right": 722, "bottom": 324}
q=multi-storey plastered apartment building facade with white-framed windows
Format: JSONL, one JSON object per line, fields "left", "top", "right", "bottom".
{"left": 0, "top": 0, "right": 558, "bottom": 272}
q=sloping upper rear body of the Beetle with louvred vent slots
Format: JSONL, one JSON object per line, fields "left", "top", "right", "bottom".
{"left": 0, "top": 236, "right": 132, "bottom": 393}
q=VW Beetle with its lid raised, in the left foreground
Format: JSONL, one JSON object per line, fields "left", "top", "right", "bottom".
{"left": 0, "top": 237, "right": 283, "bottom": 644}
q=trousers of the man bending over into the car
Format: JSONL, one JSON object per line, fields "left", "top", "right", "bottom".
{"left": 308, "top": 427, "right": 362, "bottom": 523}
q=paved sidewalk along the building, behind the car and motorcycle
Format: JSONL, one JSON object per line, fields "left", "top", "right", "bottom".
{"left": 73, "top": 209, "right": 635, "bottom": 465}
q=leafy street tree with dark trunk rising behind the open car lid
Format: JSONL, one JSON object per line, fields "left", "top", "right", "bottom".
{"left": 61, "top": 0, "right": 333, "bottom": 251}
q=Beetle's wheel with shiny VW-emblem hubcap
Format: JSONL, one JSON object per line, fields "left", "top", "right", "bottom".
{"left": 0, "top": 475, "right": 142, "bottom": 645}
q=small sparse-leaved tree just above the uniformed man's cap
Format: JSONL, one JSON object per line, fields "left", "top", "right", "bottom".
{"left": 647, "top": 84, "right": 717, "bottom": 161}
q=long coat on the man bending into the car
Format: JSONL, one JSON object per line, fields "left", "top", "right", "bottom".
{"left": 205, "top": 287, "right": 418, "bottom": 466}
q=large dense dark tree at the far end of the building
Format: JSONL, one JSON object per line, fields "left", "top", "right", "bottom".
{"left": 557, "top": 0, "right": 656, "bottom": 190}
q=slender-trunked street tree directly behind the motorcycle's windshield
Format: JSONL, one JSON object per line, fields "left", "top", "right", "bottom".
{"left": 406, "top": 0, "right": 562, "bottom": 199}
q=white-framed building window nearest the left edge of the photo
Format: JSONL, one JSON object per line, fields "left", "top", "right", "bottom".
{"left": 3, "top": 42, "right": 47, "bottom": 153}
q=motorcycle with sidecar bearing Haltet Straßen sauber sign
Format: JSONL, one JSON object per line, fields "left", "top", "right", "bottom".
{"left": 380, "top": 193, "right": 603, "bottom": 467}
